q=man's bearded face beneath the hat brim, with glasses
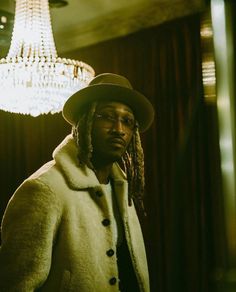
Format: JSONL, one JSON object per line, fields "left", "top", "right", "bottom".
{"left": 92, "top": 102, "right": 135, "bottom": 164}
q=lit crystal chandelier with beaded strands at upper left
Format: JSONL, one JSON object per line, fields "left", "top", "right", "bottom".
{"left": 0, "top": 0, "right": 94, "bottom": 116}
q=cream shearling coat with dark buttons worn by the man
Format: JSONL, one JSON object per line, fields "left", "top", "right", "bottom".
{"left": 0, "top": 135, "right": 149, "bottom": 292}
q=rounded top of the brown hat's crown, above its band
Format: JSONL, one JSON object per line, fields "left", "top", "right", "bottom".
{"left": 89, "top": 73, "right": 133, "bottom": 89}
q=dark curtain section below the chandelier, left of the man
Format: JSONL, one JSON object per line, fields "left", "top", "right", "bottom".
{"left": 0, "top": 111, "right": 70, "bottom": 217}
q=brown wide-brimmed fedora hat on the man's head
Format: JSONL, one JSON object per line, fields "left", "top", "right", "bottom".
{"left": 62, "top": 73, "right": 154, "bottom": 132}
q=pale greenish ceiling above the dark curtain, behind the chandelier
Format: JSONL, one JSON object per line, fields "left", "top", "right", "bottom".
{"left": 0, "top": 0, "right": 206, "bottom": 54}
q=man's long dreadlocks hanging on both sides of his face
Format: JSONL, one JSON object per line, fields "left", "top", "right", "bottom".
{"left": 72, "top": 103, "right": 145, "bottom": 211}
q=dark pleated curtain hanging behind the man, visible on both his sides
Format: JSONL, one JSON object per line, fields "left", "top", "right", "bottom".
{"left": 0, "top": 15, "right": 222, "bottom": 292}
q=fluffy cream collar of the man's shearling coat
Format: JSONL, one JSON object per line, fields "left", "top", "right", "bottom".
{"left": 53, "top": 135, "right": 127, "bottom": 189}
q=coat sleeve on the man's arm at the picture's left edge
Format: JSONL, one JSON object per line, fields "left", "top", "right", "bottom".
{"left": 0, "top": 180, "right": 60, "bottom": 292}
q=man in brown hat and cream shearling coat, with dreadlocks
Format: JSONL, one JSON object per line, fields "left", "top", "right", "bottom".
{"left": 0, "top": 73, "right": 154, "bottom": 292}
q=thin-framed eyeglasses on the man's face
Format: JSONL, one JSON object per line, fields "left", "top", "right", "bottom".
{"left": 95, "top": 113, "right": 136, "bottom": 131}
